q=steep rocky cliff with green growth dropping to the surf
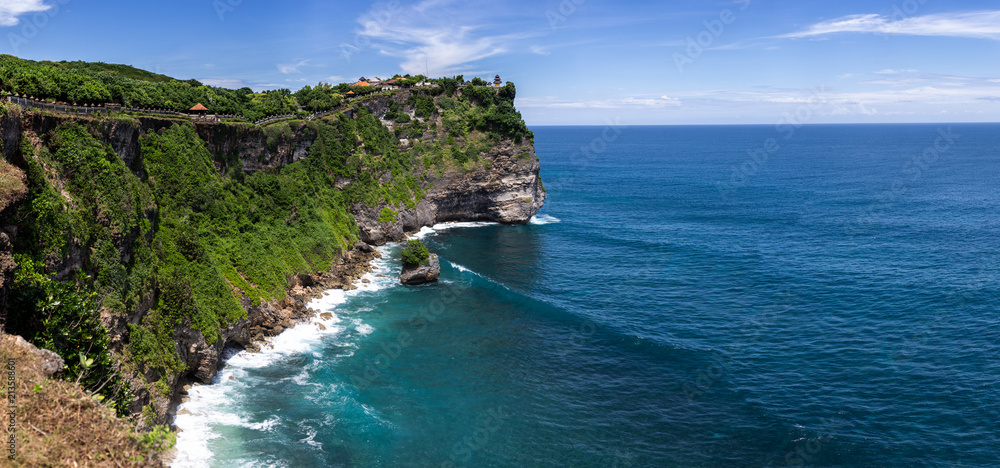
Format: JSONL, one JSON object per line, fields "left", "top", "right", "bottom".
{"left": 0, "top": 85, "right": 545, "bottom": 436}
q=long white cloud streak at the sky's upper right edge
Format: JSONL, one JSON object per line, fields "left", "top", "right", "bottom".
{"left": 779, "top": 11, "right": 1000, "bottom": 40}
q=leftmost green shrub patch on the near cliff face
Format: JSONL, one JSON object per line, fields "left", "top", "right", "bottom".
{"left": 19, "top": 124, "right": 155, "bottom": 310}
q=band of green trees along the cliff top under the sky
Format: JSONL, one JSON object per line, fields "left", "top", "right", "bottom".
{"left": 0, "top": 55, "right": 533, "bottom": 143}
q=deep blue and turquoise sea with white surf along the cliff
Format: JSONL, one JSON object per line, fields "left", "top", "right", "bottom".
{"left": 174, "top": 124, "right": 1000, "bottom": 468}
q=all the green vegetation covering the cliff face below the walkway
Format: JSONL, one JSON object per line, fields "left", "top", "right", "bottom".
{"left": 8, "top": 98, "right": 423, "bottom": 398}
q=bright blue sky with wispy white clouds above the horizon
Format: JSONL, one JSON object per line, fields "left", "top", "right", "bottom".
{"left": 0, "top": 0, "right": 1000, "bottom": 126}
